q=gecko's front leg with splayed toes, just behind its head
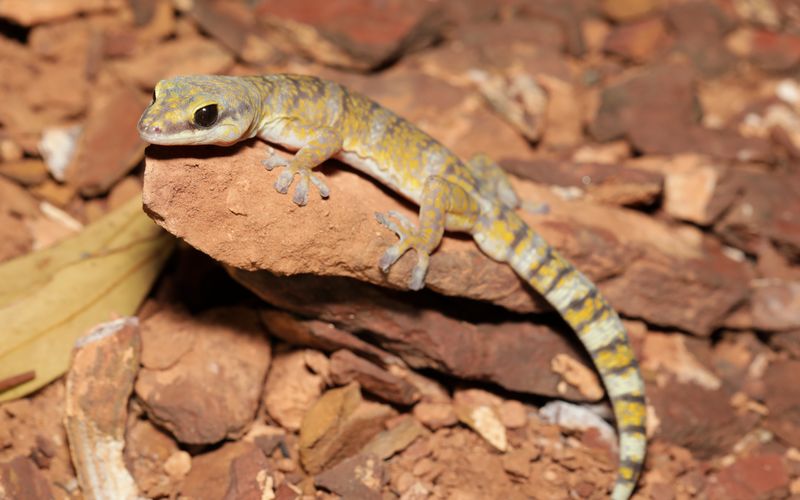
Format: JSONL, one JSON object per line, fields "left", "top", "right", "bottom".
{"left": 262, "top": 122, "right": 342, "bottom": 206}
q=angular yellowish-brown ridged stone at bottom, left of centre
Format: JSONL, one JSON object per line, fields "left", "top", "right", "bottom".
{"left": 299, "top": 383, "right": 395, "bottom": 474}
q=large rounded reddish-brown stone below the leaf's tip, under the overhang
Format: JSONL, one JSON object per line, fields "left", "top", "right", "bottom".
{"left": 135, "top": 308, "right": 270, "bottom": 444}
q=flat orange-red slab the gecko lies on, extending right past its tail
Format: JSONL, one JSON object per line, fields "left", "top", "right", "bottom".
{"left": 143, "top": 135, "right": 746, "bottom": 333}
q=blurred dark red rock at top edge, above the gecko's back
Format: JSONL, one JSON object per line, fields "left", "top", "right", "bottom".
{"left": 255, "top": 0, "right": 446, "bottom": 70}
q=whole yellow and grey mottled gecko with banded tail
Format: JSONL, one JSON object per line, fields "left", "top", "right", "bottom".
{"left": 138, "top": 74, "right": 647, "bottom": 500}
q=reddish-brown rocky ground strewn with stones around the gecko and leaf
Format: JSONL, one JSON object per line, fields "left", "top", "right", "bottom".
{"left": 0, "top": 0, "right": 800, "bottom": 500}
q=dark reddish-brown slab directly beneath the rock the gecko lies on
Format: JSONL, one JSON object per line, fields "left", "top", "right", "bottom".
{"left": 231, "top": 270, "right": 591, "bottom": 400}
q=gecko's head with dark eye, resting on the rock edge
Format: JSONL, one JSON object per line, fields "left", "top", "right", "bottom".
{"left": 137, "top": 75, "right": 259, "bottom": 145}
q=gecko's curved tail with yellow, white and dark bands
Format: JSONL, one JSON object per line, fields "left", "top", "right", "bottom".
{"left": 473, "top": 210, "right": 646, "bottom": 500}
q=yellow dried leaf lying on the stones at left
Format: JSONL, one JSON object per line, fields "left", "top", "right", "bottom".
{"left": 0, "top": 197, "right": 174, "bottom": 402}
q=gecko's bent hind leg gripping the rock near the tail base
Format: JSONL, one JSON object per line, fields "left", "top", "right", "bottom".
{"left": 375, "top": 176, "right": 478, "bottom": 290}
